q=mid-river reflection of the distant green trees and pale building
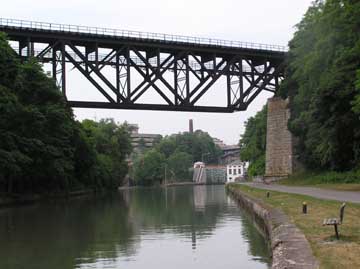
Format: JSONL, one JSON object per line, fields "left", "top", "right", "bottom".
{"left": 125, "top": 186, "right": 226, "bottom": 241}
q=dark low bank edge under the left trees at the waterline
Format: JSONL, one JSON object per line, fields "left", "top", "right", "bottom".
{"left": 0, "top": 189, "right": 96, "bottom": 207}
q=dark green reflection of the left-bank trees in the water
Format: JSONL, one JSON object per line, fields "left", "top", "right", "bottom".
{"left": 0, "top": 196, "right": 136, "bottom": 269}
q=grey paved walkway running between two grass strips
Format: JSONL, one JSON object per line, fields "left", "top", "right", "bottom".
{"left": 242, "top": 183, "right": 360, "bottom": 203}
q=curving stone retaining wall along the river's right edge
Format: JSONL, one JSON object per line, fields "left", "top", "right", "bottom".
{"left": 227, "top": 185, "right": 319, "bottom": 269}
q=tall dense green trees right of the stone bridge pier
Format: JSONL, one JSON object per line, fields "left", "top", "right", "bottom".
{"left": 281, "top": 0, "right": 360, "bottom": 171}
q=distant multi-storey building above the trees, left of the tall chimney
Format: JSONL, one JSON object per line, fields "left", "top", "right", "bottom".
{"left": 128, "top": 124, "right": 162, "bottom": 152}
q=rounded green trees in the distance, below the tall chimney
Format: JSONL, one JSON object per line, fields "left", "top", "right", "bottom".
{"left": 133, "top": 131, "right": 221, "bottom": 186}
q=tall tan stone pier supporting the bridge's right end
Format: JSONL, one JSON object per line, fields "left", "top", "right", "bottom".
{"left": 265, "top": 97, "right": 297, "bottom": 181}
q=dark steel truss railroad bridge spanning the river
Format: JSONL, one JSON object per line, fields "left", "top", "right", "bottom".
{"left": 0, "top": 18, "right": 286, "bottom": 112}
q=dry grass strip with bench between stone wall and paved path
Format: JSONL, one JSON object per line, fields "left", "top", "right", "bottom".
{"left": 230, "top": 184, "right": 360, "bottom": 269}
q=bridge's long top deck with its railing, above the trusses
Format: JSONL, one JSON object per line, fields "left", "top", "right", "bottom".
{"left": 0, "top": 18, "right": 287, "bottom": 58}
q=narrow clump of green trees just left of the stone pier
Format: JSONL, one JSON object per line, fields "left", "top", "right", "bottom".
{"left": 239, "top": 106, "right": 267, "bottom": 176}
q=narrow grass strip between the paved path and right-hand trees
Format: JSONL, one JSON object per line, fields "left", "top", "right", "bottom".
{"left": 279, "top": 171, "right": 360, "bottom": 191}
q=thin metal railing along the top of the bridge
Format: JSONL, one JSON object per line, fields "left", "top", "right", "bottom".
{"left": 0, "top": 18, "right": 288, "bottom": 52}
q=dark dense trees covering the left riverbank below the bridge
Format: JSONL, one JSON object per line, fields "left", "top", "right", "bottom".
{"left": 0, "top": 33, "right": 130, "bottom": 193}
